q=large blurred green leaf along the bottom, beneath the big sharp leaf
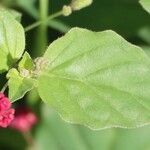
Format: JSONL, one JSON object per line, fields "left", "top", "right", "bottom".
{"left": 34, "top": 106, "right": 150, "bottom": 150}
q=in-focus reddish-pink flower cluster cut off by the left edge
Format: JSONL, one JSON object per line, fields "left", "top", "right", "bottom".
{"left": 0, "top": 93, "right": 15, "bottom": 128}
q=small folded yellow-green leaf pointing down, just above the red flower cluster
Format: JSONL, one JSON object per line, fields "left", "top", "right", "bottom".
{"left": 7, "top": 69, "right": 36, "bottom": 102}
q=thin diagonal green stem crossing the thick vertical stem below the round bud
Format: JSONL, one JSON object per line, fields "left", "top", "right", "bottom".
{"left": 25, "top": 11, "right": 62, "bottom": 32}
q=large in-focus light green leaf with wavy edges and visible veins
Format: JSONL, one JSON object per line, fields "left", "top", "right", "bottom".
{"left": 38, "top": 28, "right": 150, "bottom": 129}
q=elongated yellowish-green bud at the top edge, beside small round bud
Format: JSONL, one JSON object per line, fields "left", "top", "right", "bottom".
{"left": 71, "top": 0, "right": 93, "bottom": 10}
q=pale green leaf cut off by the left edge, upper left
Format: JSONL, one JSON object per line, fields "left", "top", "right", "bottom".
{"left": 0, "top": 10, "right": 25, "bottom": 72}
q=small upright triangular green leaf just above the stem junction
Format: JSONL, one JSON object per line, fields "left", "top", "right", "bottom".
{"left": 18, "top": 52, "right": 34, "bottom": 70}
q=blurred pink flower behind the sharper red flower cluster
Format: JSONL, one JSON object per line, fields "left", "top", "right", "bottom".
{"left": 10, "top": 108, "right": 37, "bottom": 132}
